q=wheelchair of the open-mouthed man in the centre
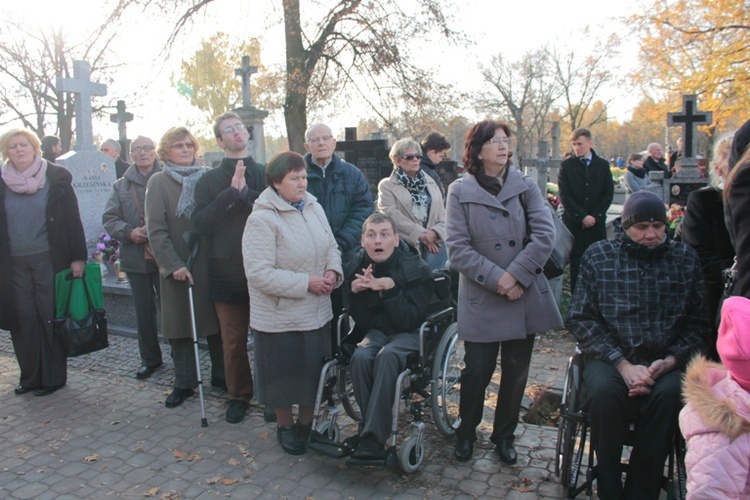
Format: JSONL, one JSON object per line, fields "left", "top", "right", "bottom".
{"left": 308, "top": 273, "right": 464, "bottom": 473}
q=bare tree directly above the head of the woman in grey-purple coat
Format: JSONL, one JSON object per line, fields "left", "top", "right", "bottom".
{"left": 477, "top": 49, "right": 559, "bottom": 158}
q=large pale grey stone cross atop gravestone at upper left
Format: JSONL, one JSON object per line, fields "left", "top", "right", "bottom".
{"left": 56, "top": 61, "right": 107, "bottom": 151}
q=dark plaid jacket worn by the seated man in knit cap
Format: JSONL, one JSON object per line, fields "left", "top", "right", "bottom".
{"left": 565, "top": 232, "right": 710, "bottom": 366}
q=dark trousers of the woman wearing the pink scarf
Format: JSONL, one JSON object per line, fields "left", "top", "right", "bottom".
{"left": 10, "top": 252, "right": 68, "bottom": 389}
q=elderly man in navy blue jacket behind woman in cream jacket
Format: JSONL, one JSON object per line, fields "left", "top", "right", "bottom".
{"left": 305, "top": 123, "right": 373, "bottom": 350}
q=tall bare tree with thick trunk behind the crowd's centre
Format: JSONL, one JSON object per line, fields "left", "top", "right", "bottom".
{"left": 112, "top": 0, "right": 459, "bottom": 152}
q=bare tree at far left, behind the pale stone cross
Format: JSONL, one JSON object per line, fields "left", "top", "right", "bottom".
{"left": 0, "top": 20, "right": 116, "bottom": 151}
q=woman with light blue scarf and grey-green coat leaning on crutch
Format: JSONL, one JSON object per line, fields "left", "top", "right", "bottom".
{"left": 146, "top": 127, "right": 226, "bottom": 408}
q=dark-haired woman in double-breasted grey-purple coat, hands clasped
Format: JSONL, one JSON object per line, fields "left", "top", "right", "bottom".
{"left": 446, "top": 120, "right": 562, "bottom": 464}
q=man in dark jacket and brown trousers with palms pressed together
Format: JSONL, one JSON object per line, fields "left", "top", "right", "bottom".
{"left": 191, "top": 112, "right": 265, "bottom": 424}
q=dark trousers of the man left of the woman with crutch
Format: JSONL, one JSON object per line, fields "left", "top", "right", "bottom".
{"left": 128, "top": 271, "right": 162, "bottom": 366}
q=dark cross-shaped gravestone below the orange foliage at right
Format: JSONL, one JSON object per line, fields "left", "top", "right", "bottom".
{"left": 648, "top": 94, "right": 713, "bottom": 206}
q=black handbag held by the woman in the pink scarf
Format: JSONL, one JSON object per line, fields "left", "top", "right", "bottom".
{"left": 52, "top": 276, "right": 109, "bottom": 358}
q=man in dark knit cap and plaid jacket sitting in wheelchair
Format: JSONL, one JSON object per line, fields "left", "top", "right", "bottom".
{"left": 565, "top": 191, "right": 709, "bottom": 499}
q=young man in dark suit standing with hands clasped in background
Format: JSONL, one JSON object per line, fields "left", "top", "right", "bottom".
{"left": 558, "top": 128, "right": 615, "bottom": 292}
